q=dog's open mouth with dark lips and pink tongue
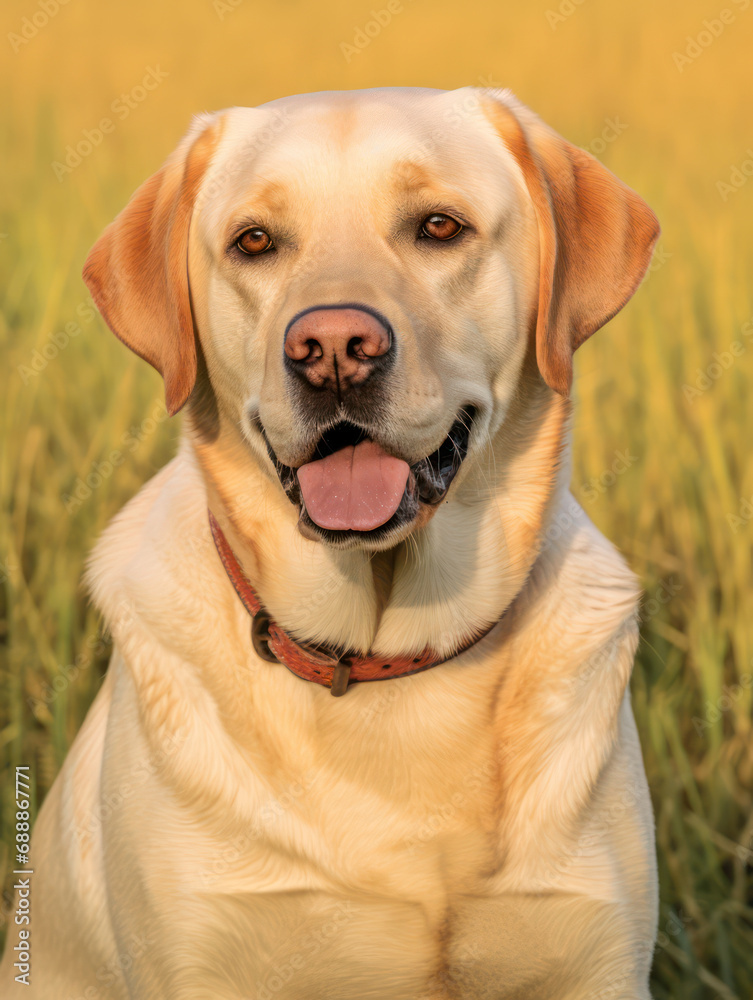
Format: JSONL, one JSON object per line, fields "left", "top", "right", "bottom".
{"left": 268, "top": 406, "right": 476, "bottom": 544}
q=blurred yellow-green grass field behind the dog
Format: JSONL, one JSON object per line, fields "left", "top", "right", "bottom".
{"left": 0, "top": 0, "right": 753, "bottom": 1000}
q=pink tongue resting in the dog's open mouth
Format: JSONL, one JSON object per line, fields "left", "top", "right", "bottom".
{"left": 298, "top": 441, "right": 410, "bottom": 531}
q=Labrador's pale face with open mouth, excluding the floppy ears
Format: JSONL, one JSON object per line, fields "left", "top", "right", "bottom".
{"left": 190, "top": 91, "right": 538, "bottom": 546}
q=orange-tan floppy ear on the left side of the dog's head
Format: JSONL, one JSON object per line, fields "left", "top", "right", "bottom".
{"left": 84, "top": 121, "right": 220, "bottom": 416}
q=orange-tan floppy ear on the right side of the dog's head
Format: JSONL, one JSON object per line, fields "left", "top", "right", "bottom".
{"left": 484, "top": 94, "right": 660, "bottom": 396}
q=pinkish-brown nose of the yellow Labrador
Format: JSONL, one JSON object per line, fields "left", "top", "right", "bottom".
{"left": 285, "top": 306, "right": 392, "bottom": 394}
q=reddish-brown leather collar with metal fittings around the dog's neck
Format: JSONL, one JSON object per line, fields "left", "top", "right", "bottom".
{"left": 209, "top": 510, "right": 496, "bottom": 697}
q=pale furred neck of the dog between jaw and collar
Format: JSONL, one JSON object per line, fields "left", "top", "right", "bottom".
{"left": 186, "top": 372, "right": 570, "bottom": 656}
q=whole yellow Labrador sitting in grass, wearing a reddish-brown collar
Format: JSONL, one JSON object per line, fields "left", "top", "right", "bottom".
{"left": 2, "top": 88, "right": 659, "bottom": 1000}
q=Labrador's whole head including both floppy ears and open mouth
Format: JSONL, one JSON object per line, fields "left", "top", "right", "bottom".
{"left": 84, "top": 88, "right": 659, "bottom": 549}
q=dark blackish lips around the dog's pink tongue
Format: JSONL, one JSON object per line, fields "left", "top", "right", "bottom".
{"left": 254, "top": 404, "right": 477, "bottom": 534}
